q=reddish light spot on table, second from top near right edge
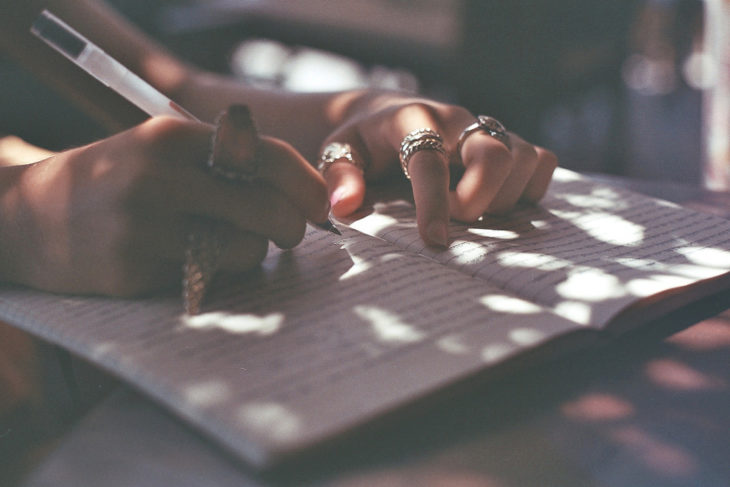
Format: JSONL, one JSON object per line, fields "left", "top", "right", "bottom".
{"left": 644, "top": 359, "right": 728, "bottom": 392}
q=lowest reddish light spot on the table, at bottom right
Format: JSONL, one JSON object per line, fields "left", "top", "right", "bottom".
{"left": 611, "top": 426, "right": 698, "bottom": 479}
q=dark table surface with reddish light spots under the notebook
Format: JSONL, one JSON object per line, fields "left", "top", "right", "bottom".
{"left": 0, "top": 176, "right": 730, "bottom": 487}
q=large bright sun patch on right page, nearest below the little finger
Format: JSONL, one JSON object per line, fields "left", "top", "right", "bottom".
{"left": 552, "top": 209, "right": 646, "bottom": 247}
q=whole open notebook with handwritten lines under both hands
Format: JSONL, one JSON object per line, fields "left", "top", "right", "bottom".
{"left": 0, "top": 169, "right": 730, "bottom": 467}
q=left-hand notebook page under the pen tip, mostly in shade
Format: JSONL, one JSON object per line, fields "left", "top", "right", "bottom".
{"left": 0, "top": 225, "right": 575, "bottom": 465}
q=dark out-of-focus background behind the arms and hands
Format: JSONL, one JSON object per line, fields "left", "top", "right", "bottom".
{"left": 0, "top": 0, "right": 707, "bottom": 183}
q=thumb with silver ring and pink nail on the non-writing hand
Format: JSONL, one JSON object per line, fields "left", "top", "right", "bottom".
{"left": 321, "top": 127, "right": 366, "bottom": 217}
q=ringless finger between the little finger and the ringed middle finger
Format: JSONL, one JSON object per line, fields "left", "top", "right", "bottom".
{"left": 486, "top": 134, "right": 538, "bottom": 214}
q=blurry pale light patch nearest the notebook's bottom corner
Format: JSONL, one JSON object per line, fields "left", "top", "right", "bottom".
{"left": 238, "top": 401, "right": 302, "bottom": 442}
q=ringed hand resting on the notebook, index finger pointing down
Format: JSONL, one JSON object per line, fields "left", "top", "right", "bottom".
{"left": 323, "top": 93, "right": 558, "bottom": 246}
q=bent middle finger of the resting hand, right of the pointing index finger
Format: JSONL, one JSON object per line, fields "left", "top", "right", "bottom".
{"left": 449, "top": 132, "right": 515, "bottom": 222}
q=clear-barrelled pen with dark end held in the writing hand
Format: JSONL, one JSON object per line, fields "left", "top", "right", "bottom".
{"left": 30, "top": 10, "right": 342, "bottom": 235}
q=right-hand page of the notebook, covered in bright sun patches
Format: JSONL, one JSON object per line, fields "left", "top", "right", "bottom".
{"left": 344, "top": 169, "right": 730, "bottom": 327}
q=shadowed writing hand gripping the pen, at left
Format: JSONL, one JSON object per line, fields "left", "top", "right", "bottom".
{"left": 0, "top": 118, "right": 329, "bottom": 296}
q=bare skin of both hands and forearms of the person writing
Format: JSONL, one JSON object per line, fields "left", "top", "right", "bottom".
{"left": 0, "top": 0, "right": 557, "bottom": 295}
